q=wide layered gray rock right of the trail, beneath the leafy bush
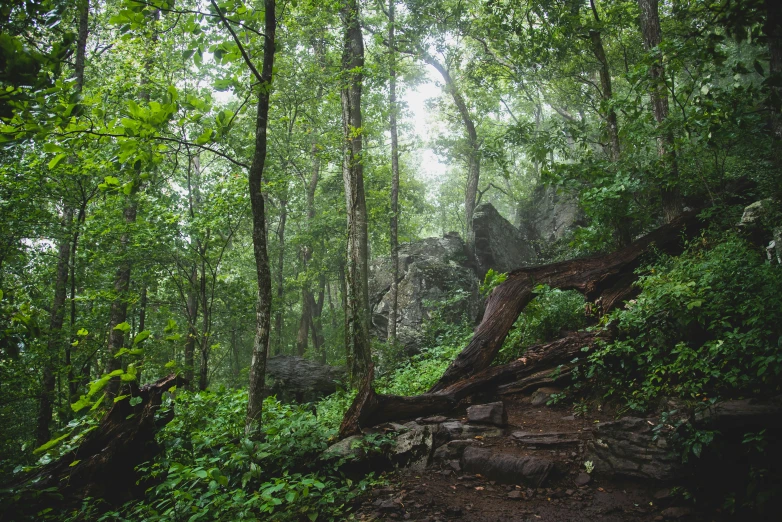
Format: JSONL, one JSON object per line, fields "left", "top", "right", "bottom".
{"left": 587, "top": 417, "right": 682, "bottom": 481}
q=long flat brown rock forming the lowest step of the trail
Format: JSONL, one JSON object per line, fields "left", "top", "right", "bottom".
{"left": 462, "top": 446, "right": 554, "bottom": 487}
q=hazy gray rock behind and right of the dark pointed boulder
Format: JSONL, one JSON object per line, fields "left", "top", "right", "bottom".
{"left": 518, "top": 185, "right": 585, "bottom": 249}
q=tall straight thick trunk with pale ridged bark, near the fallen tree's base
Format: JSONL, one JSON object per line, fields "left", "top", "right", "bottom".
{"left": 340, "top": 0, "right": 372, "bottom": 384}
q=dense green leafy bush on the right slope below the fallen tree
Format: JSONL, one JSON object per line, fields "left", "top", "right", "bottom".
{"left": 582, "top": 234, "right": 782, "bottom": 410}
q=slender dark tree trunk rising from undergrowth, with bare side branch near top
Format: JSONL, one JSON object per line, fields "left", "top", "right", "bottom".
{"left": 247, "top": 0, "right": 277, "bottom": 436}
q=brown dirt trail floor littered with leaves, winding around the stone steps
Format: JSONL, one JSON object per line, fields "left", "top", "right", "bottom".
{"left": 355, "top": 397, "right": 720, "bottom": 522}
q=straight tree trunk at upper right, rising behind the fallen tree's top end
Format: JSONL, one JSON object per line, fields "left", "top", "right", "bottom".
{"left": 638, "top": 0, "right": 682, "bottom": 223}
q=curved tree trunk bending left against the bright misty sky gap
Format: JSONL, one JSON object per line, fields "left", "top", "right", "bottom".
{"left": 424, "top": 55, "right": 481, "bottom": 247}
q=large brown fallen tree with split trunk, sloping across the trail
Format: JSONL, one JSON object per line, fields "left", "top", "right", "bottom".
{"left": 340, "top": 212, "right": 701, "bottom": 437}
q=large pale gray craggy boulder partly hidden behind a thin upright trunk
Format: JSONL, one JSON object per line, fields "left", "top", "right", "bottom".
{"left": 369, "top": 233, "right": 483, "bottom": 353}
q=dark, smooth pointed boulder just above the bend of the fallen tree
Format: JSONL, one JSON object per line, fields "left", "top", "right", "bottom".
{"left": 472, "top": 203, "right": 537, "bottom": 279}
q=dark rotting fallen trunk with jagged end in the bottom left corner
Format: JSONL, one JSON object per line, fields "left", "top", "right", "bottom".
{"left": 4, "top": 375, "right": 184, "bottom": 519}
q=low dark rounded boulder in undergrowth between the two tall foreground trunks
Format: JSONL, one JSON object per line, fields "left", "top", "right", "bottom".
{"left": 266, "top": 355, "right": 345, "bottom": 402}
